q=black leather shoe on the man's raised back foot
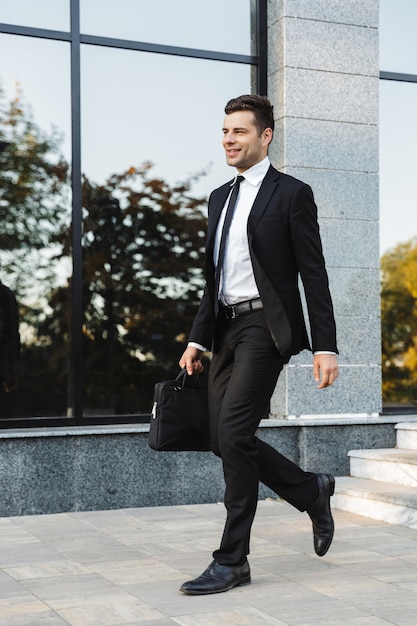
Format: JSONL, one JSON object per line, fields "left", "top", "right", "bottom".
{"left": 307, "top": 474, "right": 335, "bottom": 556}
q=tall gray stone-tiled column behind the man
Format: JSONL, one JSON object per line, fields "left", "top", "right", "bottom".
{"left": 268, "top": 0, "right": 381, "bottom": 417}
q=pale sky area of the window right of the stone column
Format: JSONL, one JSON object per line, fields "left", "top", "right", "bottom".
{"left": 379, "top": 0, "right": 417, "bottom": 254}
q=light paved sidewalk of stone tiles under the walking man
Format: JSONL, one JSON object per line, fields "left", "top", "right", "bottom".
{"left": 0, "top": 501, "right": 417, "bottom": 626}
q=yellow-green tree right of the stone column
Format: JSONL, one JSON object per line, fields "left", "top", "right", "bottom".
{"left": 381, "top": 238, "right": 417, "bottom": 404}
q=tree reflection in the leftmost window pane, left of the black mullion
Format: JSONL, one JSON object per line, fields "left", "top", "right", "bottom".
{"left": 0, "top": 83, "right": 70, "bottom": 417}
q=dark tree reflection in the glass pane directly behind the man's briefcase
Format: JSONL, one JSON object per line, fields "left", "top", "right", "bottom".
{"left": 76, "top": 163, "right": 206, "bottom": 413}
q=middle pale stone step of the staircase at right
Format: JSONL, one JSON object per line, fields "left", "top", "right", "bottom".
{"left": 348, "top": 448, "right": 417, "bottom": 487}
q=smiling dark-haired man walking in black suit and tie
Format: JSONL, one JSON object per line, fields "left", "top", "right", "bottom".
{"left": 180, "top": 95, "right": 338, "bottom": 595}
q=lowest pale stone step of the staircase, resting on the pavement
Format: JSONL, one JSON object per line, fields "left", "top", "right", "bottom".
{"left": 331, "top": 476, "right": 417, "bottom": 528}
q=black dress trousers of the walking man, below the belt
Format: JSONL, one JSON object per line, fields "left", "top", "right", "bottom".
{"left": 209, "top": 310, "right": 318, "bottom": 565}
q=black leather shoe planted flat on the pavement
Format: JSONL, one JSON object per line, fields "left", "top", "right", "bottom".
{"left": 180, "top": 561, "right": 250, "bottom": 596}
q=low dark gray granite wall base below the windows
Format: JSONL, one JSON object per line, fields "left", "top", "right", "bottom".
{"left": 0, "top": 418, "right": 400, "bottom": 517}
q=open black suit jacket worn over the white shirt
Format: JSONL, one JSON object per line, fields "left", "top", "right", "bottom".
{"left": 189, "top": 166, "right": 337, "bottom": 355}
